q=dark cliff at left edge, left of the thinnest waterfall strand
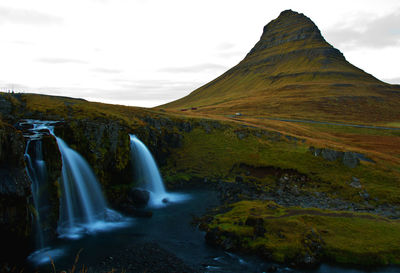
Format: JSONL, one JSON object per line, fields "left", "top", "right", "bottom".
{"left": 0, "top": 123, "right": 33, "bottom": 261}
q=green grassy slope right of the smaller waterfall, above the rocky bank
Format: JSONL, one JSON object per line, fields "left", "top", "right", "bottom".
{"left": 163, "top": 128, "right": 400, "bottom": 204}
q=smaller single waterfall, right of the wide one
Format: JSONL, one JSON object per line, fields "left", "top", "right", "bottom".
{"left": 129, "top": 135, "right": 188, "bottom": 207}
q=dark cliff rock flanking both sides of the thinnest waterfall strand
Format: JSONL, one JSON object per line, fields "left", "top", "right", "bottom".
{"left": 0, "top": 118, "right": 62, "bottom": 264}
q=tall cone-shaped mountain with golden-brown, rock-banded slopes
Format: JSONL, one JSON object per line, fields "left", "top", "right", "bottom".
{"left": 161, "top": 10, "right": 400, "bottom": 123}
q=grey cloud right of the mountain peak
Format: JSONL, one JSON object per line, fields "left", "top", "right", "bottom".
{"left": 325, "top": 10, "right": 400, "bottom": 48}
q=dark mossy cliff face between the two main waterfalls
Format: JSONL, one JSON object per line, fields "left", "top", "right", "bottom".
{"left": 55, "top": 119, "right": 132, "bottom": 200}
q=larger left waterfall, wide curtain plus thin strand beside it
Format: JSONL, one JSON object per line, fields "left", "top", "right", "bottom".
{"left": 25, "top": 120, "right": 129, "bottom": 264}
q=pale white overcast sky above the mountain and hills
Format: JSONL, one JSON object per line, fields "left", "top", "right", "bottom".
{"left": 0, "top": 0, "right": 400, "bottom": 107}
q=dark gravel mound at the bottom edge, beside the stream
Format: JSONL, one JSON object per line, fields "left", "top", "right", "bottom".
{"left": 88, "top": 242, "right": 201, "bottom": 273}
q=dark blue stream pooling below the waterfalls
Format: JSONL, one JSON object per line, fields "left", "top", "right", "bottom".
{"left": 25, "top": 189, "right": 399, "bottom": 273}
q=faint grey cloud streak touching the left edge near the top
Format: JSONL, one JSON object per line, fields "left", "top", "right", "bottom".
{"left": 0, "top": 6, "right": 63, "bottom": 25}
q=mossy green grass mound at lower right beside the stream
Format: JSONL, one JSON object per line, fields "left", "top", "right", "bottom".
{"left": 208, "top": 201, "right": 400, "bottom": 265}
